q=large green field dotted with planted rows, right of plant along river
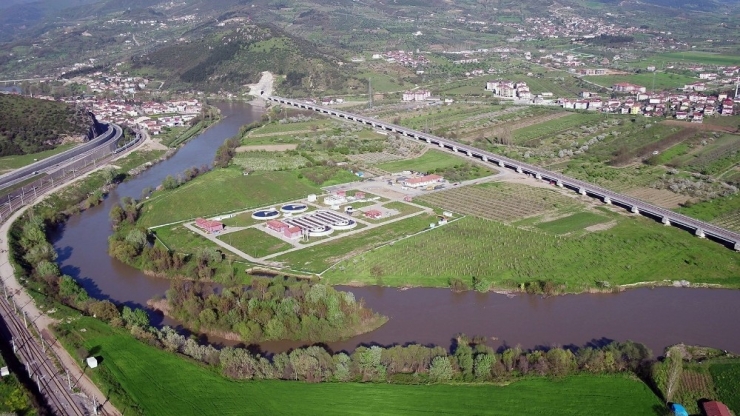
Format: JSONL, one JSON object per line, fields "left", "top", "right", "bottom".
{"left": 324, "top": 212, "right": 740, "bottom": 292}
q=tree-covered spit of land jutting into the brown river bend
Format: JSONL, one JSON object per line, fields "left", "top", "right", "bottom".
{"left": 167, "top": 277, "right": 387, "bottom": 342}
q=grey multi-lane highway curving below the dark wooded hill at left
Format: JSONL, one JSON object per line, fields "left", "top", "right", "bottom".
{"left": 0, "top": 123, "right": 123, "bottom": 189}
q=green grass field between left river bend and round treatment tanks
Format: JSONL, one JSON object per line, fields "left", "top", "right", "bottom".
{"left": 139, "top": 169, "right": 320, "bottom": 227}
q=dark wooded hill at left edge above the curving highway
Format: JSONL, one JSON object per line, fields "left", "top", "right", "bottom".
{"left": 0, "top": 94, "right": 91, "bottom": 156}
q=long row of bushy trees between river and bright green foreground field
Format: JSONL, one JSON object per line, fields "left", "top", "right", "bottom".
{"left": 124, "top": 312, "right": 652, "bottom": 384}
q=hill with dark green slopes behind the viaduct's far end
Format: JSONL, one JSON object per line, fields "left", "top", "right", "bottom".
{"left": 132, "top": 24, "right": 348, "bottom": 96}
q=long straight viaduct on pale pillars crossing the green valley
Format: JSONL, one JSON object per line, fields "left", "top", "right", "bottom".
{"left": 267, "top": 96, "right": 740, "bottom": 251}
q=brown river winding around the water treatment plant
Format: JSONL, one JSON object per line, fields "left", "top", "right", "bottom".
{"left": 53, "top": 103, "right": 740, "bottom": 354}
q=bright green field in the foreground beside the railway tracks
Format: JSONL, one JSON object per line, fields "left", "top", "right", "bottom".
{"left": 55, "top": 318, "right": 661, "bottom": 416}
